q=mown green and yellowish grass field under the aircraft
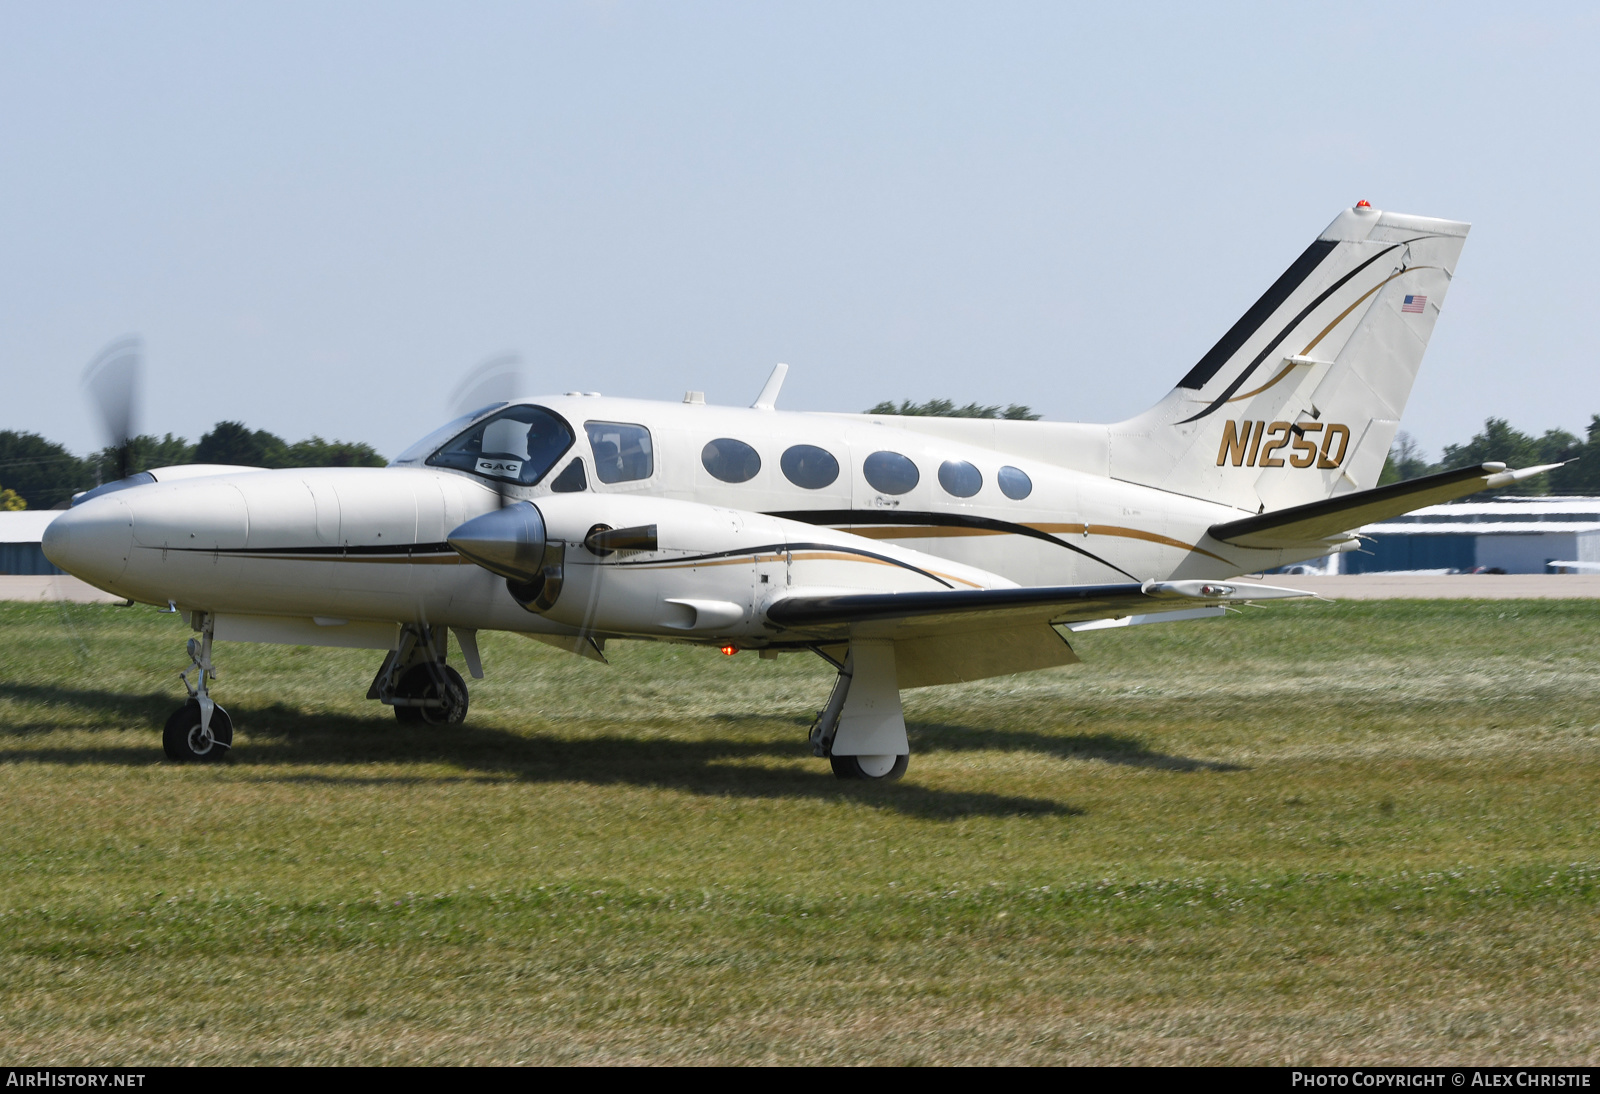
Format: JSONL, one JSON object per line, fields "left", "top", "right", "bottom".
{"left": 0, "top": 601, "right": 1600, "bottom": 1064}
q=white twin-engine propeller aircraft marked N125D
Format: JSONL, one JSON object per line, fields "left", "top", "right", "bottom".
{"left": 43, "top": 202, "right": 1544, "bottom": 779}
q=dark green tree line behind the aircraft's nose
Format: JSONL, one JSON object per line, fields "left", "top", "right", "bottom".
{"left": 0, "top": 422, "right": 389, "bottom": 510}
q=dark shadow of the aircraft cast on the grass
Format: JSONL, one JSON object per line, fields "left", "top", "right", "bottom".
{"left": 0, "top": 683, "right": 1237, "bottom": 819}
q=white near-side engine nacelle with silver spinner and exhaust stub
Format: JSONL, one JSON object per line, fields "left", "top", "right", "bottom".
{"left": 450, "top": 493, "right": 1013, "bottom": 641}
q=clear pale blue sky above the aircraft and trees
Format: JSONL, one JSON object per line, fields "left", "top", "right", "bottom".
{"left": 0, "top": 2, "right": 1600, "bottom": 456}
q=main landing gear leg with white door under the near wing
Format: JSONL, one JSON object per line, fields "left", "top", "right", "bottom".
{"left": 811, "top": 641, "right": 910, "bottom": 782}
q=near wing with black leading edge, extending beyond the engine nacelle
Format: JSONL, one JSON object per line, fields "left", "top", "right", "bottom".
{"left": 766, "top": 581, "right": 1312, "bottom": 638}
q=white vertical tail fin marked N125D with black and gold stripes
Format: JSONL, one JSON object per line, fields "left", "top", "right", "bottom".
{"left": 1110, "top": 202, "right": 1469, "bottom": 512}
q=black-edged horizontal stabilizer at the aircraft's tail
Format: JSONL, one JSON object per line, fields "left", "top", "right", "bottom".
{"left": 1211, "top": 464, "right": 1560, "bottom": 549}
